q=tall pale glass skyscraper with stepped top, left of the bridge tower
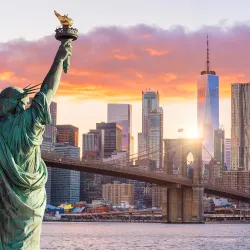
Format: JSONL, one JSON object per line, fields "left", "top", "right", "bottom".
{"left": 138, "top": 89, "right": 163, "bottom": 169}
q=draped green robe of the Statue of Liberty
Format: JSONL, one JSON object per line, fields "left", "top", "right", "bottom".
{"left": 0, "top": 92, "right": 51, "bottom": 250}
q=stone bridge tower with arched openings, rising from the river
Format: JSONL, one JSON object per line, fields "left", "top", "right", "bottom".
{"left": 162, "top": 138, "right": 204, "bottom": 223}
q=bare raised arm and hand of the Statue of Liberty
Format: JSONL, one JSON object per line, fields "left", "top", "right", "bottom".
{"left": 41, "top": 39, "right": 72, "bottom": 104}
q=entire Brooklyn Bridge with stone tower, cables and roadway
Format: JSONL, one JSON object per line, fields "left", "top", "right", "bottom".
{"left": 42, "top": 139, "right": 250, "bottom": 223}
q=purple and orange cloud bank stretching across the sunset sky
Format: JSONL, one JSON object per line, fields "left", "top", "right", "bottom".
{"left": 0, "top": 24, "right": 250, "bottom": 101}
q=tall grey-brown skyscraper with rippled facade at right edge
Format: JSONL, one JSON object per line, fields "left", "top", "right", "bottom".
{"left": 231, "top": 83, "right": 250, "bottom": 171}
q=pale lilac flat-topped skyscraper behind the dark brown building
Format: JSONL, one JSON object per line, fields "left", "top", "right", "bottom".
{"left": 107, "top": 104, "right": 133, "bottom": 155}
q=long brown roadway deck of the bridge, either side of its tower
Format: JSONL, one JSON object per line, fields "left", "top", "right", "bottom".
{"left": 42, "top": 153, "right": 250, "bottom": 203}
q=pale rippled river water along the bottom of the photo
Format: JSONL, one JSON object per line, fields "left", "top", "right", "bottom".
{"left": 41, "top": 222, "right": 250, "bottom": 250}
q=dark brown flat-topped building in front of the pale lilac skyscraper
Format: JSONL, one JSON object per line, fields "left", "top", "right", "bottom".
{"left": 96, "top": 122, "right": 122, "bottom": 158}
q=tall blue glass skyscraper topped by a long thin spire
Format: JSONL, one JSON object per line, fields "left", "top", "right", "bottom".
{"left": 197, "top": 35, "right": 219, "bottom": 161}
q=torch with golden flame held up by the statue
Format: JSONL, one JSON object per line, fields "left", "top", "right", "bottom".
{"left": 54, "top": 11, "right": 78, "bottom": 73}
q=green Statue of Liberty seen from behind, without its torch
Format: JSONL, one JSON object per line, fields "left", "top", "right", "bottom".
{"left": 0, "top": 39, "right": 72, "bottom": 250}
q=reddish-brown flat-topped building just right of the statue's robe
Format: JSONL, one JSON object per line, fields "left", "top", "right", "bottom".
{"left": 56, "top": 125, "right": 79, "bottom": 147}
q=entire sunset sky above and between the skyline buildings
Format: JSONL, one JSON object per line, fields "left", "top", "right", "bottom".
{"left": 0, "top": 0, "right": 250, "bottom": 151}
